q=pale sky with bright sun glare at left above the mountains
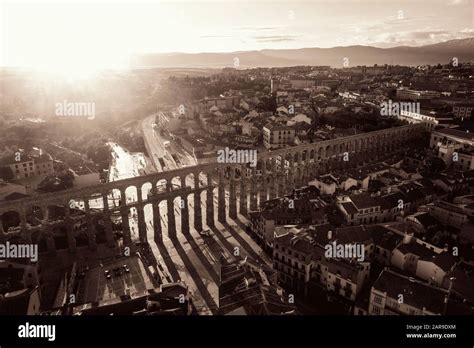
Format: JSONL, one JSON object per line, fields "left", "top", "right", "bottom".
{"left": 0, "top": 0, "right": 474, "bottom": 72}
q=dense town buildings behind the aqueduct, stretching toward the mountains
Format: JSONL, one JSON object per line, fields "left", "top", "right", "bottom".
{"left": 173, "top": 63, "right": 474, "bottom": 166}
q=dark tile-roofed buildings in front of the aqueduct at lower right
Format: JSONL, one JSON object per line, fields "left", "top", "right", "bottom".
{"left": 249, "top": 144, "right": 474, "bottom": 314}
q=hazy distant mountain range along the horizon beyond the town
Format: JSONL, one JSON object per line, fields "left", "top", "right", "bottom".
{"left": 131, "top": 38, "right": 474, "bottom": 68}
